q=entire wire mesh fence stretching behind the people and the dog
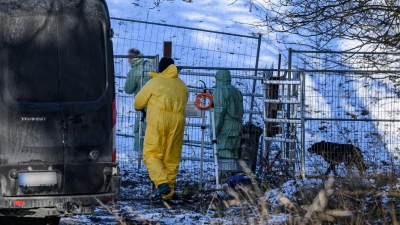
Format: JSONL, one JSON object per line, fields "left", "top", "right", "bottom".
{"left": 112, "top": 18, "right": 400, "bottom": 186}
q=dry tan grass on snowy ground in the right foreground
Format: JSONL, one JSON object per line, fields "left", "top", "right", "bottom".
{"left": 103, "top": 163, "right": 400, "bottom": 225}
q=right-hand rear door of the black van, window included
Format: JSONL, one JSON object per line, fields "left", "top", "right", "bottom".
{"left": 58, "top": 13, "right": 114, "bottom": 193}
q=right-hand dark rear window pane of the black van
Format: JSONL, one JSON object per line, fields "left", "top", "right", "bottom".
{"left": 58, "top": 16, "right": 107, "bottom": 102}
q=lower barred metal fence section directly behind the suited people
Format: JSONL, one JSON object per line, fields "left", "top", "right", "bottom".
{"left": 116, "top": 64, "right": 262, "bottom": 186}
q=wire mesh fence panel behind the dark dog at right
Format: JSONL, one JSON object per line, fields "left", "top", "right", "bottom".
{"left": 292, "top": 51, "right": 400, "bottom": 176}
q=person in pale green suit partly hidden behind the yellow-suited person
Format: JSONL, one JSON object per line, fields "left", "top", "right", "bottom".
{"left": 124, "top": 48, "right": 151, "bottom": 151}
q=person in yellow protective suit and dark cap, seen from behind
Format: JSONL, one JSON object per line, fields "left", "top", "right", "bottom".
{"left": 134, "top": 57, "right": 189, "bottom": 200}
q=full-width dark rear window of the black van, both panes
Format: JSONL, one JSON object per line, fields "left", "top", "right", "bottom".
{"left": 0, "top": 15, "right": 107, "bottom": 102}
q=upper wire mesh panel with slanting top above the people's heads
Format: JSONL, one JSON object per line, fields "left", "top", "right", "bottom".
{"left": 111, "top": 18, "right": 261, "bottom": 67}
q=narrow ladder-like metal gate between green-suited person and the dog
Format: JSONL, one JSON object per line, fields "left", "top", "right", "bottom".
{"left": 262, "top": 70, "right": 304, "bottom": 179}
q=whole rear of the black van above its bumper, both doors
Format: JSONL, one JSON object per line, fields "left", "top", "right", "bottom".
{"left": 0, "top": 0, "right": 114, "bottom": 196}
